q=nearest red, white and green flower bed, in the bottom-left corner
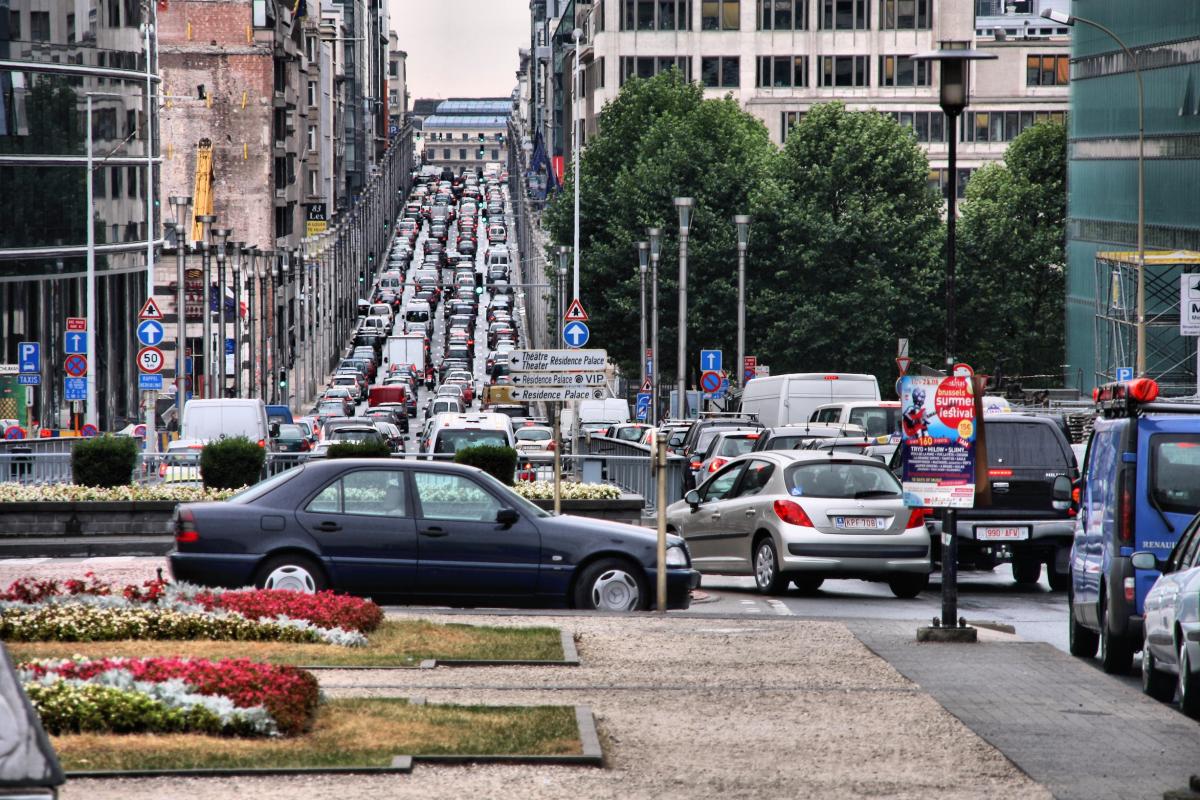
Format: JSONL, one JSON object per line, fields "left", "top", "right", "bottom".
{"left": 17, "top": 658, "right": 320, "bottom": 736}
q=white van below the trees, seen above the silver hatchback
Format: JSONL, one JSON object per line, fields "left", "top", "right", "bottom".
{"left": 742, "top": 372, "right": 880, "bottom": 428}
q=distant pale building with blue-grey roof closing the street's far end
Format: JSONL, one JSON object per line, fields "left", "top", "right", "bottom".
{"left": 421, "top": 97, "right": 512, "bottom": 173}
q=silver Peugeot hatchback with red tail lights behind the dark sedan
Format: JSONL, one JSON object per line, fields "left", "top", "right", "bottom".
{"left": 667, "top": 451, "right": 932, "bottom": 597}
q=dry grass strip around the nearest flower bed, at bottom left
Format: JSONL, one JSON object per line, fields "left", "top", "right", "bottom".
{"left": 50, "top": 698, "right": 583, "bottom": 771}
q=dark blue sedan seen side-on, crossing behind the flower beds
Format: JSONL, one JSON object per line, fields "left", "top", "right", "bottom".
{"left": 170, "top": 459, "right": 700, "bottom": 610}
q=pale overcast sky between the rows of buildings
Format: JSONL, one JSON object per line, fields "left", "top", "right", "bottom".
{"left": 389, "top": 0, "right": 529, "bottom": 100}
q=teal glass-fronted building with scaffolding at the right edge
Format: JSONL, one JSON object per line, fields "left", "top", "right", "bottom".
{"left": 1064, "top": 0, "right": 1200, "bottom": 395}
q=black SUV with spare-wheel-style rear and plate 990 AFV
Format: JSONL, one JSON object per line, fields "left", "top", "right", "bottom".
{"left": 907, "top": 413, "right": 1079, "bottom": 591}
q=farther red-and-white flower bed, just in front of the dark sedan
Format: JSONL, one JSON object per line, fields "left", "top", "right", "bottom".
{"left": 0, "top": 573, "right": 383, "bottom": 646}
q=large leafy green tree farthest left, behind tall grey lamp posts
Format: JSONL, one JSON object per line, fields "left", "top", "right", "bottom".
{"left": 545, "top": 70, "right": 776, "bottom": 383}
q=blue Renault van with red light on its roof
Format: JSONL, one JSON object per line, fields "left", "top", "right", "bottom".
{"left": 1068, "top": 378, "right": 1200, "bottom": 673}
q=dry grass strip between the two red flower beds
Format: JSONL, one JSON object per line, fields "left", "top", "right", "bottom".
{"left": 6, "top": 619, "right": 564, "bottom": 667}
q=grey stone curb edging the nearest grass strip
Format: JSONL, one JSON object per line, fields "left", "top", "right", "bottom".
{"left": 66, "top": 697, "right": 604, "bottom": 780}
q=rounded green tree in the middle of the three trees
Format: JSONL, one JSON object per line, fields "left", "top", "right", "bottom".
{"left": 746, "top": 103, "right": 943, "bottom": 383}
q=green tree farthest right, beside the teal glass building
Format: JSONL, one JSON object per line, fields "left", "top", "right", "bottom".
{"left": 958, "top": 122, "right": 1067, "bottom": 385}
